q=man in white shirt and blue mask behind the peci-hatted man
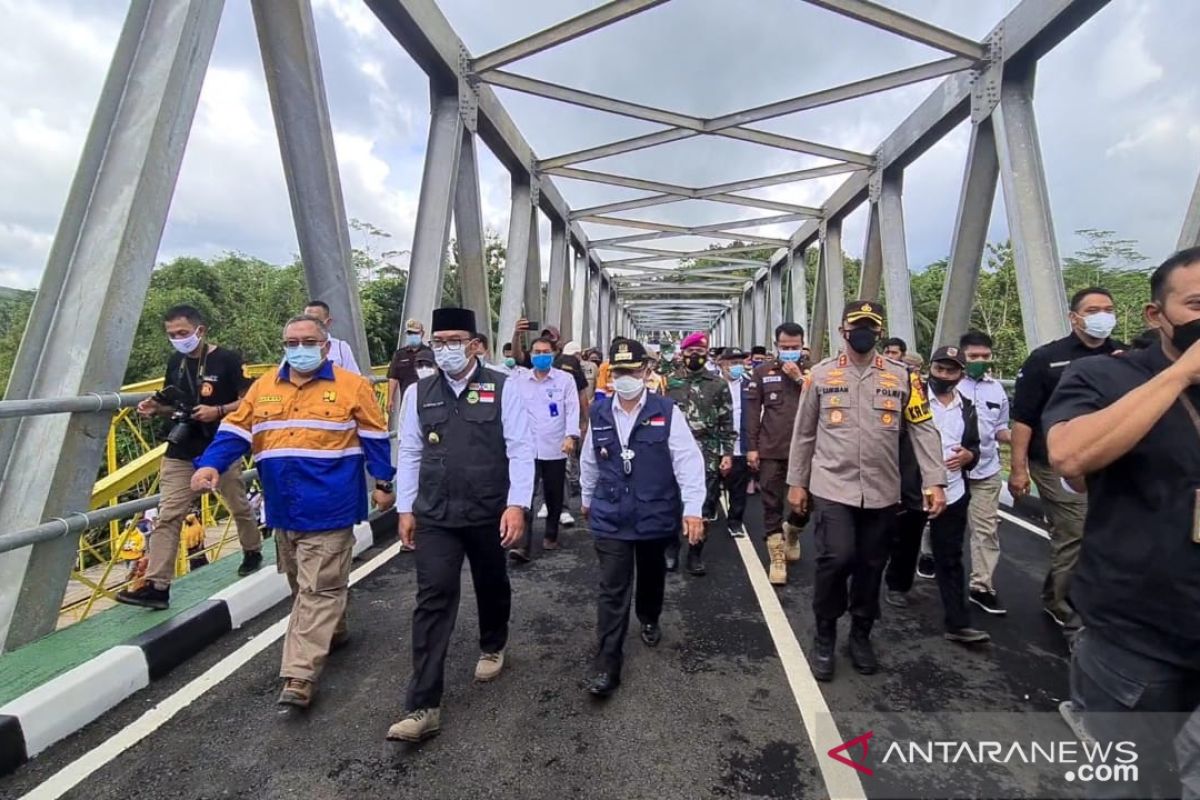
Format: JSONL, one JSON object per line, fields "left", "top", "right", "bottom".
{"left": 509, "top": 337, "right": 580, "bottom": 563}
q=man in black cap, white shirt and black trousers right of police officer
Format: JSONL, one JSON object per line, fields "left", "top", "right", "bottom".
{"left": 928, "top": 347, "right": 991, "bottom": 644}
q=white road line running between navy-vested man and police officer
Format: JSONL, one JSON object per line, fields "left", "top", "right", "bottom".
{"left": 722, "top": 498, "right": 866, "bottom": 800}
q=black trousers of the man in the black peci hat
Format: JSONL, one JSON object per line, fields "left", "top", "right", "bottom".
{"left": 408, "top": 517, "right": 512, "bottom": 710}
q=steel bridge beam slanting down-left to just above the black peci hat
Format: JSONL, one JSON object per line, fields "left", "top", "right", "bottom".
{"left": 403, "top": 90, "right": 458, "bottom": 341}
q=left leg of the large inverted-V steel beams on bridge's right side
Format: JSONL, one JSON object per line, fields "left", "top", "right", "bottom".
{"left": 934, "top": 118, "right": 1000, "bottom": 349}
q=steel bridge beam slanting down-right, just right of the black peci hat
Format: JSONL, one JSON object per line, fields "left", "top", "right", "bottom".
{"left": 454, "top": 130, "right": 498, "bottom": 340}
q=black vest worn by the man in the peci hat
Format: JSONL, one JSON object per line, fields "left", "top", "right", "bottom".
{"left": 413, "top": 366, "right": 509, "bottom": 528}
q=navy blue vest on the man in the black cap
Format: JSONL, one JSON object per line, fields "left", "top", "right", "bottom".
{"left": 588, "top": 392, "right": 683, "bottom": 540}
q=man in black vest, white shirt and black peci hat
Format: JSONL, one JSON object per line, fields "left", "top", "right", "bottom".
{"left": 388, "top": 308, "right": 534, "bottom": 741}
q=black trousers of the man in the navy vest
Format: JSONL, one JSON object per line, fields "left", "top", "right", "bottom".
{"left": 593, "top": 534, "right": 678, "bottom": 675}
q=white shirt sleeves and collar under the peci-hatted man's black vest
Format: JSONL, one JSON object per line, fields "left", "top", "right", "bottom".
{"left": 396, "top": 360, "right": 535, "bottom": 513}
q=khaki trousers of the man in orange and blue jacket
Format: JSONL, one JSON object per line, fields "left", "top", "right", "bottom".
{"left": 275, "top": 528, "right": 354, "bottom": 681}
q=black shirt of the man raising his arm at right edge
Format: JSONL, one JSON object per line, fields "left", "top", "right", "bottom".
{"left": 1042, "top": 344, "right": 1200, "bottom": 669}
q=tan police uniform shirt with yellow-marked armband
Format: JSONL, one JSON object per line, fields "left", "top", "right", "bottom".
{"left": 787, "top": 353, "right": 946, "bottom": 509}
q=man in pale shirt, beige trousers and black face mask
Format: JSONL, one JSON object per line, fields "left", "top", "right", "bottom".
{"left": 959, "top": 331, "right": 1013, "bottom": 614}
